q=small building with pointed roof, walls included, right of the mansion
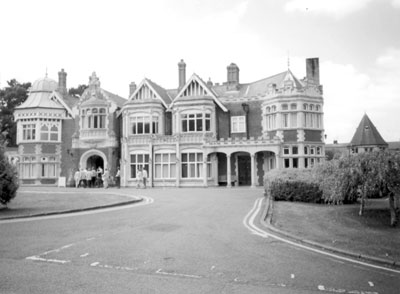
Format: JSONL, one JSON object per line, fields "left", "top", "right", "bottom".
{"left": 348, "top": 114, "right": 389, "bottom": 154}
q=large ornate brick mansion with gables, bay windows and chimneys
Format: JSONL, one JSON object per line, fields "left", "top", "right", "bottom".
{"left": 14, "top": 58, "right": 325, "bottom": 187}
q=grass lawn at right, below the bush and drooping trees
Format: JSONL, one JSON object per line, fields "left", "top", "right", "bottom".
{"left": 272, "top": 199, "right": 400, "bottom": 262}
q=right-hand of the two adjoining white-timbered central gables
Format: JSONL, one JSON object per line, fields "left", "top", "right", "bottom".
{"left": 170, "top": 74, "right": 228, "bottom": 112}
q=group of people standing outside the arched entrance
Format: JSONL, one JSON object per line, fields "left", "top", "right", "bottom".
{"left": 74, "top": 166, "right": 119, "bottom": 189}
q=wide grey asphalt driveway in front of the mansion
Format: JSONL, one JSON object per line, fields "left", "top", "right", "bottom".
{"left": 0, "top": 188, "right": 400, "bottom": 294}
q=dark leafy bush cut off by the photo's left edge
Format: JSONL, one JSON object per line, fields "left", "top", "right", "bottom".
{"left": 0, "top": 146, "right": 18, "bottom": 205}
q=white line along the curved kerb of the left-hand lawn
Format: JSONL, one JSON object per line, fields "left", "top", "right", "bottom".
{"left": 0, "top": 193, "right": 154, "bottom": 224}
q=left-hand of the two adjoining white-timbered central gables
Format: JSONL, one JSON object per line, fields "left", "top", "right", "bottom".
{"left": 128, "top": 78, "right": 172, "bottom": 108}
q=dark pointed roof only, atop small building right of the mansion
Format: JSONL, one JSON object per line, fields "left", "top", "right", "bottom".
{"left": 350, "top": 114, "right": 388, "bottom": 146}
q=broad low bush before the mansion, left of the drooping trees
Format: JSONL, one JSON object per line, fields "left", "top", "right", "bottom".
{"left": 265, "top": 169, "right": 322, "bottom": 203}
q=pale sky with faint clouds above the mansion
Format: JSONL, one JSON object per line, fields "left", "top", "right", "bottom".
{"left": 0, "top": 0, "right": 400, "bottom": 143}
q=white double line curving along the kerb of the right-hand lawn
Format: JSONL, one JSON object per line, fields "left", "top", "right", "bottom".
{"left": 243, "top": 197, "right": 400, "bottom": 274}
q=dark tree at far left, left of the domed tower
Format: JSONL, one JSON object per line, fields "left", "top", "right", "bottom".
{"left": 0, "top": 79, "right": 31, "bottom": 146}
